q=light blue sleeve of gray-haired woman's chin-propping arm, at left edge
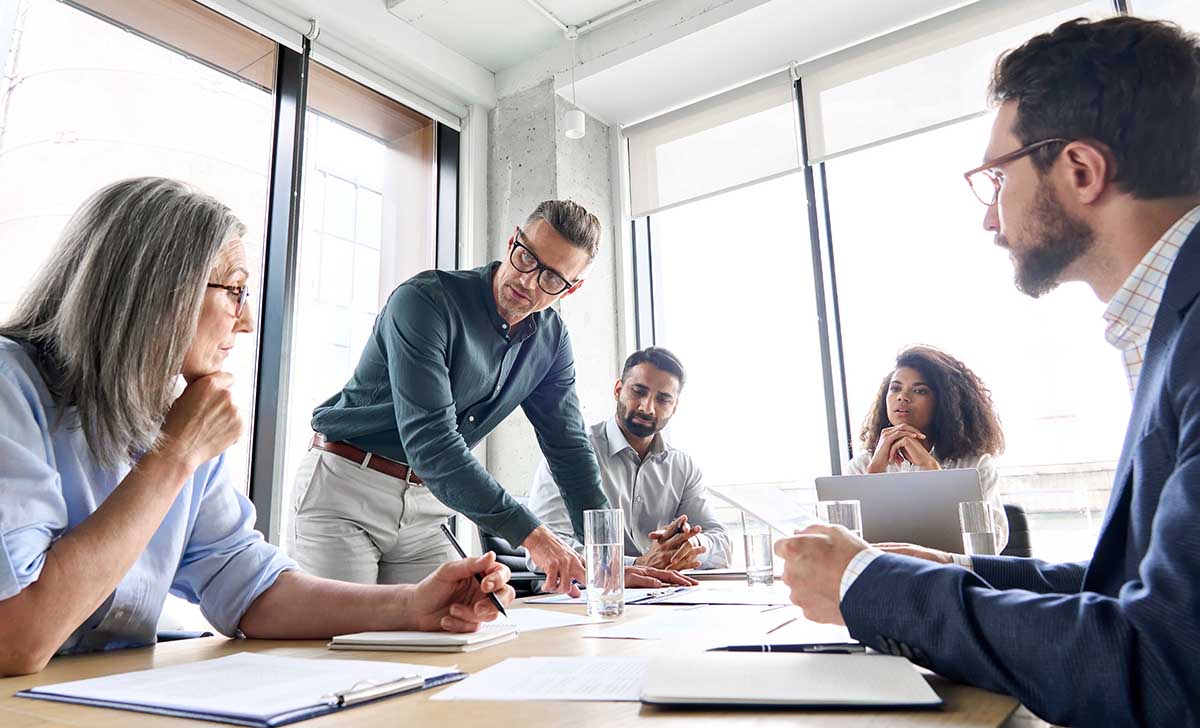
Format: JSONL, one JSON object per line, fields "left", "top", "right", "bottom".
{"left": 0, "top": 365, "right": 67, "bottom": 600}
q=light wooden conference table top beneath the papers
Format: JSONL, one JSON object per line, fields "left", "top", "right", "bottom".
{"left": 0, "top": 590, "right": 1018, "bottom": 728}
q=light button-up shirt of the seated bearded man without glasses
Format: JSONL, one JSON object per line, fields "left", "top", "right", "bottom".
{"left": 529, "top": 416, "right": 730, "bottom": 568}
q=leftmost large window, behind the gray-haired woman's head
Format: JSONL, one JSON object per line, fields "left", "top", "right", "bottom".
{"left": 0, "top": 0, "right": 276, "bottom": 491}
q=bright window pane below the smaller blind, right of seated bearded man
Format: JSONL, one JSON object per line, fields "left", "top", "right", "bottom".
{"left": 643, "top": 174, "right": 830, "bottom": 561}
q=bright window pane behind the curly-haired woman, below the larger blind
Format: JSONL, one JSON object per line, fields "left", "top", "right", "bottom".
{"left": 827, "top": 118, "right": 1129, "bottom": 559}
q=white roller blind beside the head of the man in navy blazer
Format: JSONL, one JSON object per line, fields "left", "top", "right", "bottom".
{"left": 799, "top": 0, "right": 1112, "bottom": 163}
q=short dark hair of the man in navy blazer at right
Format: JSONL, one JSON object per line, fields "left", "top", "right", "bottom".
{"left": 989, "top": 16, "right": 1200, "bottom": 199}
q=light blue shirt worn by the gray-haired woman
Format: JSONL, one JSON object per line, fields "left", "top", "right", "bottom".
{"left": 0, "top": 337, "right": 296, "bottom": 654}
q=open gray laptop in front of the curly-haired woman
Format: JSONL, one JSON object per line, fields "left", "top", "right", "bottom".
{"left": 817, "top": 468, "right": 983, "bottom": 554}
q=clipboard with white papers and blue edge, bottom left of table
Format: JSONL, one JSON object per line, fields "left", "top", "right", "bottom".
{"left": 17, "top": 652, "right": 467, "bottom": 728}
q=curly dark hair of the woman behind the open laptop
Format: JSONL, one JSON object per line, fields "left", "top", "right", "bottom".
{"left": 859, "top": 345, "right": 1004, "bottom": 461}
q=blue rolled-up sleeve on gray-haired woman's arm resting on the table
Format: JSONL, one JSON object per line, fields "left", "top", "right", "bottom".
{"left": 170, "top": 456, "right": 296, "bottom": 636}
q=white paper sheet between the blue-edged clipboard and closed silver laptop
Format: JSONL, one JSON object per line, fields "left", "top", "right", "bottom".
{"left": 430, "top": 656, "right": 649, "bottom": 703}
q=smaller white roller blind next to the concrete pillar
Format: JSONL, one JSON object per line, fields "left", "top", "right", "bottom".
{"left": 625, "top": 72, "right": 800, "bottom": 217}
